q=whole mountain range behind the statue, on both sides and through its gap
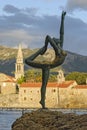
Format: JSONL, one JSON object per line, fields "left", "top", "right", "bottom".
{"left": 0, "top": 46, "right": 87, "bottom": 75}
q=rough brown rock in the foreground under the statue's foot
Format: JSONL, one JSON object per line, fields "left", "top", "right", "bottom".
{"left": 12, "top": 109, "right": 87, "bottom": 130}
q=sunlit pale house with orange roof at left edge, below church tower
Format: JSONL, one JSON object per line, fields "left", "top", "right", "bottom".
{"left": 0, "top": 73, "right": 17, "bottom": 94}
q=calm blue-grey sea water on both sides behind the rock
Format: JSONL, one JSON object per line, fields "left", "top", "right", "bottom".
{"left": 0, "top": 109, "right": 87, "bottom": 130}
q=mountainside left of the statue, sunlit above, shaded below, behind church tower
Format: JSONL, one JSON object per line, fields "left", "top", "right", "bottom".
{"left": 0, "top": 46, "right": 35, "bottom": 75}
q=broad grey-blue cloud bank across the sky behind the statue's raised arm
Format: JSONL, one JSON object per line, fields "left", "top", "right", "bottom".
{"left": 0, "top": 4, "right": 87, "bottom": 55}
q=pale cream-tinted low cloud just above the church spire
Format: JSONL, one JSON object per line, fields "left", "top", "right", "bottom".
{"left": 0, "top": 29, "right": 40, "bottom": 47}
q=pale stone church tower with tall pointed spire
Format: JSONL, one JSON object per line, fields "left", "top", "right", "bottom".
{"left": 15, "top": 44, "right": 24, "bottom": 79}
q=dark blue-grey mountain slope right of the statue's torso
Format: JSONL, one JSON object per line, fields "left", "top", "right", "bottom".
{"left": 62, "top": 52, "right": 87, "bottom": 72}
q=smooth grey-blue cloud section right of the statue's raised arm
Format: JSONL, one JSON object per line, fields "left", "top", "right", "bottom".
{"left": 64, "top": 16, "right": 87, "bottom": 55}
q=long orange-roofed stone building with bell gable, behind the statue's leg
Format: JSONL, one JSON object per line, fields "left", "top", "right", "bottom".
{"left": 19, "top": 66, "right": 87, "bottom": 108}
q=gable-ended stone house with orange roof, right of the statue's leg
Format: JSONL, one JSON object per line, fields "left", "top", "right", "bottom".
{"left": 58, "top": 80, "right": 77, "bottom": 108}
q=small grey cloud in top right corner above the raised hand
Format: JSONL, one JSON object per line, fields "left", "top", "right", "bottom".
{"left": 66, "top": 0, "right": 87, "bottom": 11}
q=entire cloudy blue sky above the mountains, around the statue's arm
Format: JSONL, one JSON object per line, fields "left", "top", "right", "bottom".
{"left": 0, "top": 0, "right": 87, "bottom": 56}
